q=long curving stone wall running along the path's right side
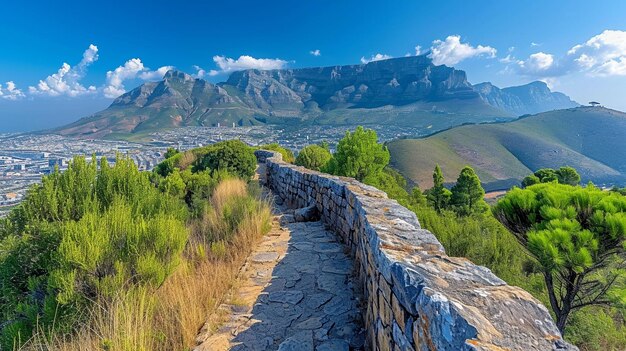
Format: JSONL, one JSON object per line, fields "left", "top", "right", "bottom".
{"left": 256, "top": 151, "right": 576, "bottom": 351}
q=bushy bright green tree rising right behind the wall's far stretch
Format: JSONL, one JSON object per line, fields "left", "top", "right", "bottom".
{"left": 326, "top": 126, "right": 389, "bottom": 181}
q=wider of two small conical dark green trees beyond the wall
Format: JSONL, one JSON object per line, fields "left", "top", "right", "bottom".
{"left": 450, "top": 166, "right": 488, "bottom": 216}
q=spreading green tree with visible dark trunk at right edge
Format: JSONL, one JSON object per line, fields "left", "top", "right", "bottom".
{"left": 493, "top": 183, "right": 626, "bottom": 333}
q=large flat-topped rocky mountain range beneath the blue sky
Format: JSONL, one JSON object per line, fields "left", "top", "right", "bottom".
{"left": 56, "top": 55, "right": 571, "bottom": 138}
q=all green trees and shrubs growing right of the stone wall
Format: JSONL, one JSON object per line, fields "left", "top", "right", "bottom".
{"left": 294, "top": 128, "right": 626, "bottom": 350}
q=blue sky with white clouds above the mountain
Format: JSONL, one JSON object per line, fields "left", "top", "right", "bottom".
{"left": 0, "top": 0, "right": 626, "bottom": 131}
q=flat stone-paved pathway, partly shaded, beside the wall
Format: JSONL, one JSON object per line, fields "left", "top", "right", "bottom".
{"left": 195, "top": 199, "right": 365, "bottom": 351}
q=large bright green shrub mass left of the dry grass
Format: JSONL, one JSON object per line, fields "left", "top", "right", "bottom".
{"left": 0, "top": 156, "right": 187, "bottom": 349}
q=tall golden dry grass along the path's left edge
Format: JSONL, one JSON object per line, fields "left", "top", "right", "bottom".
{"left": 21, "top": 179, "right": 271, "bottom": 351}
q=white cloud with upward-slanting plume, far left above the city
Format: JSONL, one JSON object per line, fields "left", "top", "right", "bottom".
{"left": 28, "top": 44, "right": 98, "bottom": 97}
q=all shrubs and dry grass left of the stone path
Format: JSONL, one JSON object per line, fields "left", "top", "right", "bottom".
{"left": 0, "top": 142, "right": 270, "bottom": 351}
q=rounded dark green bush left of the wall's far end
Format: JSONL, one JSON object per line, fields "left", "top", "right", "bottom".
{"left": 193, "top": 140, "right": 256, "bottom": 179}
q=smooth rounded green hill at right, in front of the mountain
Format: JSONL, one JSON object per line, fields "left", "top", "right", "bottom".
{"left": 389, "top": 107, "right": 626, "bottom": 190}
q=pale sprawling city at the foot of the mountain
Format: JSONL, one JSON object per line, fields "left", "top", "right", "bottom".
{"left": 0, "top": 125, "right": 424, "bottom": 217}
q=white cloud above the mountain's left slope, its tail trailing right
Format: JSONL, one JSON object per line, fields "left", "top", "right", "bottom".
{"left": 102, "top": 58, "right": 174, "bottom": 99}
